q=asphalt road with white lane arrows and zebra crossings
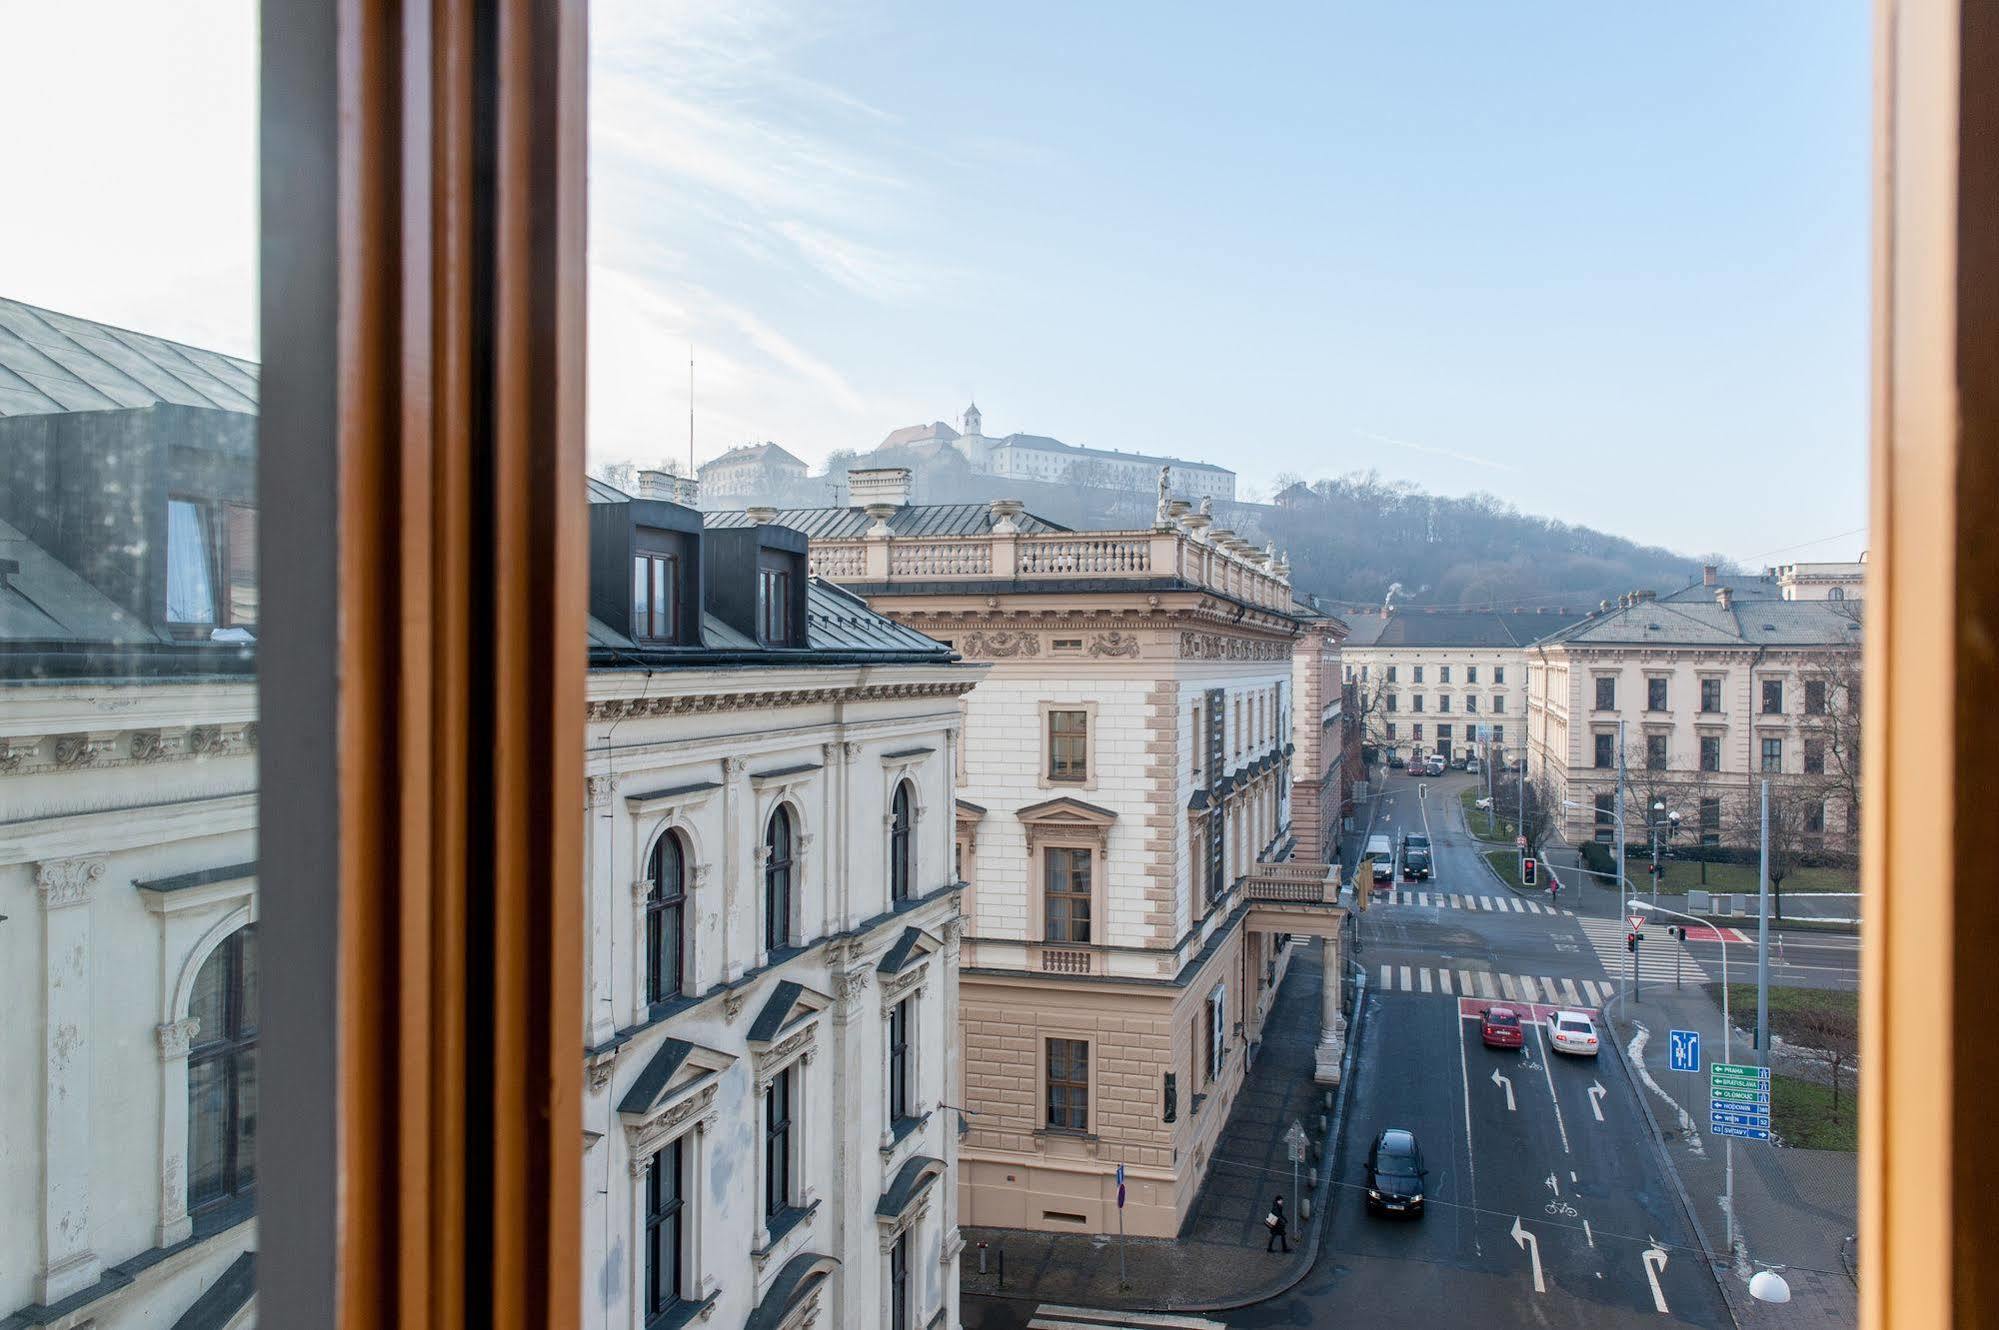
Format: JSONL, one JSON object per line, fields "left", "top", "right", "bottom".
{"left": 966, "top": 774, "right": 1731, "bottom": 1330}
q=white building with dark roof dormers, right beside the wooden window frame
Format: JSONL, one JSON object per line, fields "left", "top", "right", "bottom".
{"left": 584, "top": 486, "right": 984, "bottom": 1330}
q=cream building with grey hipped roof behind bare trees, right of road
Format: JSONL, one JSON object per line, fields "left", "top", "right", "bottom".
{"left": 1527, "top": 584, "right": 1861, "bottom": 846}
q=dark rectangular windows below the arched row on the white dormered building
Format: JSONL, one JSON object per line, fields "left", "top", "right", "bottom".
{"left": 642, "top": 998, "right": 916, "bottom": 1330}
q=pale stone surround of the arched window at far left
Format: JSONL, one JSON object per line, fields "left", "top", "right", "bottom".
{"left": 146, "top": 876, "right": 258, "bottom": 1248}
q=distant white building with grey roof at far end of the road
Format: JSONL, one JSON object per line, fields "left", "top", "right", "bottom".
{"left": 1339, "top": 608, "right": 1575, "bottom": 762}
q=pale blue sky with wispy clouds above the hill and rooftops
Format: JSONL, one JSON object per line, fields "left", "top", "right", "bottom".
{"left": 0, "top": 0, "right": 1871, "bottom": 562}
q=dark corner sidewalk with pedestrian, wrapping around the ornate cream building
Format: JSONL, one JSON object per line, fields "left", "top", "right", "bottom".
{"left": 960, "top": 944, "right": 1359, "bottom": 1312}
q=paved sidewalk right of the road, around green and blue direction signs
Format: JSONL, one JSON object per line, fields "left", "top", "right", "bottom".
{"left": 1609, "top": 984, "right": 1859, "bottom": 1328}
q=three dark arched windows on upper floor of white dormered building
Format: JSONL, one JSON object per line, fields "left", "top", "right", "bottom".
{"left": 646, "top": 780, "right": 916, "bottom": 1006}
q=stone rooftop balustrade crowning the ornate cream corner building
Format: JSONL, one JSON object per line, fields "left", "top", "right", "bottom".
{"left": 812, "top": 524, "right": 1291, "bottom": 610}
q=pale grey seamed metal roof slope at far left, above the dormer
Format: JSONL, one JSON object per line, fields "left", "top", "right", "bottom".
{"left": 0, "top": 298, "right": 258, "bottom": 416}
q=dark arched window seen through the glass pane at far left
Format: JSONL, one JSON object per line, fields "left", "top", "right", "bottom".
{"left": 188, "top": 924, "right": 258, "bottom": 1214}
